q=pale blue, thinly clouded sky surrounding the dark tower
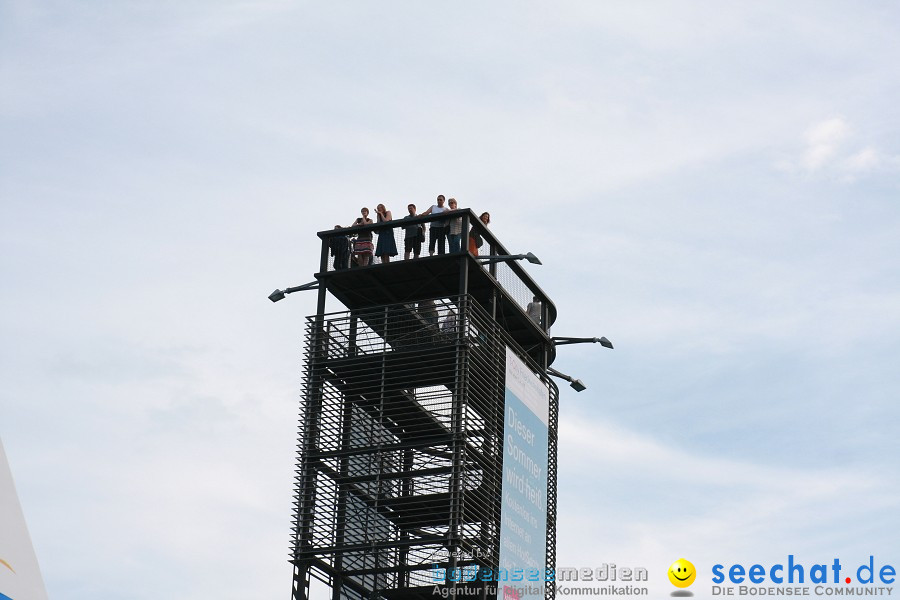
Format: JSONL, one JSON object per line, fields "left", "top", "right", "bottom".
{"left": 0, "top": 0, "right": 900, "bottom": 600}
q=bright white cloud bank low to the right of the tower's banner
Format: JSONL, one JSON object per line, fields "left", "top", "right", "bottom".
{"left": 558, "top": 418, "right": 897, "bottom": 582}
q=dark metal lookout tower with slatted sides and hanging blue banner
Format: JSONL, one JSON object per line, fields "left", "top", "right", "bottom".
{"left": 288, "top": 211, "right": 559, "bottom": 600}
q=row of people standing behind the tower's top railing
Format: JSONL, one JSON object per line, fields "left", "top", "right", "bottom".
{"left": 331, "top": 195, "right": 491, "bottom": 269}
